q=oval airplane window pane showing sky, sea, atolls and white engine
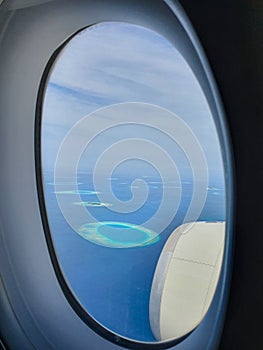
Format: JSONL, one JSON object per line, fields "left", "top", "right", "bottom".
{"left": 41, "top": 22, "right": 226, "bottom": 343}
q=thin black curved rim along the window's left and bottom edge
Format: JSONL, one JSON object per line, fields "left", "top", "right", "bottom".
{"left": 36, "top": 12, "right": 234, "bottom": 350}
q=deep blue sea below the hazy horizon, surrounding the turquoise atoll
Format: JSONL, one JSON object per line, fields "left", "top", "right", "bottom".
{"left": 44, "top": 172, "right": 225, "bottom": 341}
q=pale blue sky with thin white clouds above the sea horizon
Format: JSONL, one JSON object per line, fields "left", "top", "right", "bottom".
{"left": 42, "top": 22, "right": 226, "bottom": 183}
